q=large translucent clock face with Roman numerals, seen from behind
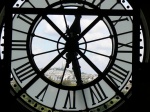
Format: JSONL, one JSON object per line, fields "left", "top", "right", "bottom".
{"left": 0, "top": 0, "right": 143, "bottom": 112}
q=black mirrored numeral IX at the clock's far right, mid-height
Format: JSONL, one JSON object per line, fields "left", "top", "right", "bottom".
{"left": 118, "top": 42, "right": 133, "bottom": 53}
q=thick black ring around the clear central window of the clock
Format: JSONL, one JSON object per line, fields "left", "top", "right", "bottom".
{"left": 27, "top": 1, "right": 118, "bottom": 90}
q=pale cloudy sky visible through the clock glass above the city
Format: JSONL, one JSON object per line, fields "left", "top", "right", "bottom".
{"left": 1, "top": 0, "right": 142, "bottom": 74}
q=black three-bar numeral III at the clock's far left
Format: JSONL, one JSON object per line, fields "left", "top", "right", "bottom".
{"left": 12, "top": 40, "right": 26, "bottom": 50}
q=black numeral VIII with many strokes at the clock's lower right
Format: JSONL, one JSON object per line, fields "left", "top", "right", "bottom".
{"left": 107, "top": 64, "right": 129, "bottom": 87}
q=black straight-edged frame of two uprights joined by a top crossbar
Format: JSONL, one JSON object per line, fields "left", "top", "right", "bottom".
{"left": 3, "top": 1, "right": 149, "bottom": 111}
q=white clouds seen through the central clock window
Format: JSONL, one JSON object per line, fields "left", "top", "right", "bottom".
{"left": 33, "top": 15, "right": 112, "bottom": 74}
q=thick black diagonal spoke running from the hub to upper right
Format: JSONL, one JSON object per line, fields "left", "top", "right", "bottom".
{"left": 78, "top": 16, "right": 102, "bottom": 40}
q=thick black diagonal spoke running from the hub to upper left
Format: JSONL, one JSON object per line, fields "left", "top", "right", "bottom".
{"left": 43, "top": 15, "right": 67, "bottom": 40}
